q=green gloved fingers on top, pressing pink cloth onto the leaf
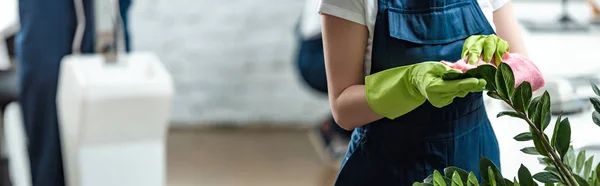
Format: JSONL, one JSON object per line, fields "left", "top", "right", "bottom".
{"left": 461, "top": 34, "right": 510, "bottom": 65}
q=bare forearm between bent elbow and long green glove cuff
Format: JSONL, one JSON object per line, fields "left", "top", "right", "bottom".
{"left": 330, "top": 85, "right": 383, "bottom": 130}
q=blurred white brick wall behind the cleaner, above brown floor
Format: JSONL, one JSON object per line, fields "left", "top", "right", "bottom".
{"left": 130, "top": 0, "right": 328, "bottom": 125}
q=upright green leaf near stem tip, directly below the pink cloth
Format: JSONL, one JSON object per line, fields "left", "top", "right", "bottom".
{"left": 495, "top": 63, "right": 515, "bottom": 100}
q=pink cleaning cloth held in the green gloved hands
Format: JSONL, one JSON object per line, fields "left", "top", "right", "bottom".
{"left": 442, "top": 53, "right": 546, "bottom": 91}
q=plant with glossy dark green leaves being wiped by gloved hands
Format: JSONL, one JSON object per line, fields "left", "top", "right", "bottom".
{"left": 413, "top": 62, "right": 600, "bottom": 186}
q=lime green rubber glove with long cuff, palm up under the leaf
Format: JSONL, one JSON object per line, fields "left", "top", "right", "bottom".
{"left": 365, "top": 62, "right": 486, "bottom": 119}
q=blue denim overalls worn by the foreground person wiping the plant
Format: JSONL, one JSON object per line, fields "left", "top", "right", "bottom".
{"left": 335, "top": 0, "right": 500, "bottom": 186}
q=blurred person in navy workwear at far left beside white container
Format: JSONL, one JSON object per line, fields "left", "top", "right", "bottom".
{"left": 16, "top": 0, "right": 131, "bottom": 186}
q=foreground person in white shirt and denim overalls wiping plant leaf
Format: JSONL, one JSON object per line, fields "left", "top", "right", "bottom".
{"left": 318, "top": 0, "right": 527, "bottom": 186}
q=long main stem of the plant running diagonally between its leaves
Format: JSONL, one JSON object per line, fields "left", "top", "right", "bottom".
{"left": 494, "top": 93, "right": 579, "bottom": 186}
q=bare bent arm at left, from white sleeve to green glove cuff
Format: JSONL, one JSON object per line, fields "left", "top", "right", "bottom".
{"left": 322, "top": 14, "right": 383, "bottom": 130}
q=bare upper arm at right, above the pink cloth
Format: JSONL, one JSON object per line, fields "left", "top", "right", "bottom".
{"left": 494, "top": 0, "right": 529, "bottom": 56}
